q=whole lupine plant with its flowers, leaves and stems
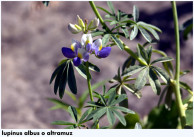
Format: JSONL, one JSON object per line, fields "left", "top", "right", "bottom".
{"left": 47, "top": 1, "right": 193, "bottom": 129}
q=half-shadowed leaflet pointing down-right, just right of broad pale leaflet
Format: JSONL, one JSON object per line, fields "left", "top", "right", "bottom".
{"left": 148, "top": 69, "right": 161, "bottom": 95}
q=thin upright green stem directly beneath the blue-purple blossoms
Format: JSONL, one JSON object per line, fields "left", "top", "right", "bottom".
{"left": 86, "top": 62, "right": 99, "bottom": 129}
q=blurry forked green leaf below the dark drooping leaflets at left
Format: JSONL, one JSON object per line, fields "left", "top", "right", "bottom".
{"left": 47, "top": 98, "right": 69, "bottom": 110}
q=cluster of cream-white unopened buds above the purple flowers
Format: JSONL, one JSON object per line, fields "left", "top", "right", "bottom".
{"left": 68, "top": 15, "right": 99, "bottom": 34}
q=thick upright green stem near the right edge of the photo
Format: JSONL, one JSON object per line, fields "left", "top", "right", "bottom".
{"left": 171, "top": 1, "right": 186, "bottom": 128}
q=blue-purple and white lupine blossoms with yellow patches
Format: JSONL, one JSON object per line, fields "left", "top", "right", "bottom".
{"left": 62, "top": 34, "right": 111, "bottom": 66}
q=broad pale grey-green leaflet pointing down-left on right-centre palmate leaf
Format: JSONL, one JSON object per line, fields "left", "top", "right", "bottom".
{"left": 135, "top": 67, "right": 149, "bottom": 90}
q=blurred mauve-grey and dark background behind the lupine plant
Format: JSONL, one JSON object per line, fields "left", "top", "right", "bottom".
{"left": 1, "top": 1, "right": 193, "bottom": 129}
